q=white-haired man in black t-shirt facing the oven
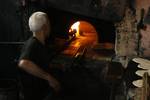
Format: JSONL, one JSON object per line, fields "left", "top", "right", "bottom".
{"left": 18, "top": 12, "right": 60, "bottom": 100}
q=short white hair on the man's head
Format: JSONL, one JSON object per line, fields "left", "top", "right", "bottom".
{"left": 29, "top": 12, "right": 48, "bottom": 32}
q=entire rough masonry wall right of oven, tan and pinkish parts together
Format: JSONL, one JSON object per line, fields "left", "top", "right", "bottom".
{"left": 115, "top": 0, "right": 150, "bottom": 68}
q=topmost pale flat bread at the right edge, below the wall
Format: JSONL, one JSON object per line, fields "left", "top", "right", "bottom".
{"left": 132, "top": 58, "right": 150, "bottom": 67}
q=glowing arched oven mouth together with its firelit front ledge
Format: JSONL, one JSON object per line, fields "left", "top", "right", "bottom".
{"left": 53, "top": 20, "right": 114, "bottom": 59}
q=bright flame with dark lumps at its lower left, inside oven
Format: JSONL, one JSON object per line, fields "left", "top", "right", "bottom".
{"left": 69, "top": 21, "right": 80, "bottom": 37}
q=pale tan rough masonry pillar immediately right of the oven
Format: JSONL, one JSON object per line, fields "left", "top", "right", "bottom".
{"left": 115, "top": 7, "right": 139, "bottom": 68}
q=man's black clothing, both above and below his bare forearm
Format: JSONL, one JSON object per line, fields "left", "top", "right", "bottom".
{"left": 19, "top": 37, "right": 52, "bottom": 99}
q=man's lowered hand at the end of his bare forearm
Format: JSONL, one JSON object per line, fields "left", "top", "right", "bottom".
{"left": 48, "top": 76, "right": 60, "bottom": 92}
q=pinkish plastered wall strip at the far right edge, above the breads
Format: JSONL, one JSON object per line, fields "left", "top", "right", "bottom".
{"left": 136, "top": 0, "right": 150, "bottom": 57}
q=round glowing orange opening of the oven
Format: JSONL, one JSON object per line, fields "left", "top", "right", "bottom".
{"left": 68, "top": 21, "right": 98, "bottom": 46}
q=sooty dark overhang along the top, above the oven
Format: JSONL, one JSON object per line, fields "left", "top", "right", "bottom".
{"left": 48, "top": 0, "right": 134, "bottom": 21}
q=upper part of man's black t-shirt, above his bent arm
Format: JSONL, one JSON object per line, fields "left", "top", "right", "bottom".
{"left": 20, "top": 37, "right": 51, "bottom": 70}
